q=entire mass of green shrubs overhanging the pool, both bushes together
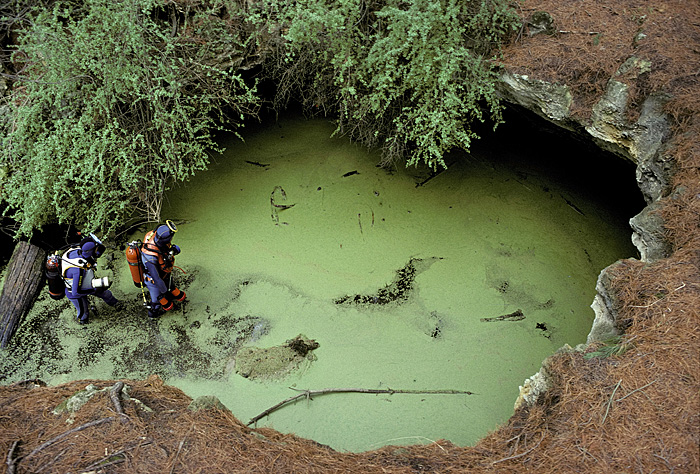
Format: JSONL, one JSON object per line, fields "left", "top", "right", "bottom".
{"left": 0, "top": 0, "right": 516, "bottom": 235}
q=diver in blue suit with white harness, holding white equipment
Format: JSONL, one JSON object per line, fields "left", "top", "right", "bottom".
{"left": 61, "top": 234, "right": 119, "bottom": 324}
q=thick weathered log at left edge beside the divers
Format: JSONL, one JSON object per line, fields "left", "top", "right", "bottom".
{"left": 0, "top": 242, "right": 46, "bottom": 348}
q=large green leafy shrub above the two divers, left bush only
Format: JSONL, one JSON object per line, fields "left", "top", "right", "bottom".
{"left": 0, "top": 0, "right": 258, "bottom": 235}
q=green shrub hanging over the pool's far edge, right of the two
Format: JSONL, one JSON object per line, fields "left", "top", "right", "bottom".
{"left": 254, "top": 0, "right": 518, "bottom": 168}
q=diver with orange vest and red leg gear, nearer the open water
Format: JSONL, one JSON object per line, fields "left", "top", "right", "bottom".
{"left": 134, "top": 220, "right": 186, "bottom": 319}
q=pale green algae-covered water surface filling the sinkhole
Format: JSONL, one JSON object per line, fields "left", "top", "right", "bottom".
{"left": 2, "top": 114, "right": 636, "bottom": 451}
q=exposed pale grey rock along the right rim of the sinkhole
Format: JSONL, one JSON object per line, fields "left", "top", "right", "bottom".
{"left": 499, "top": 66, "right": 673, "bottom": 410}
